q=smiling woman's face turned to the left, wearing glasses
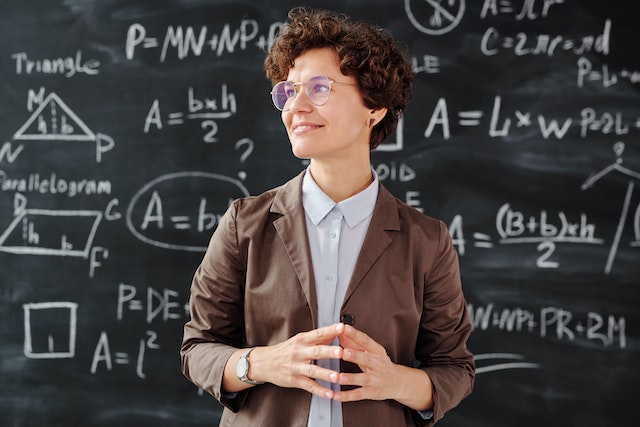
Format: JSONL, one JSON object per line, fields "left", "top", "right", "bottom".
{"left": 282, "top": 48, "right": 379, "bottom": 162}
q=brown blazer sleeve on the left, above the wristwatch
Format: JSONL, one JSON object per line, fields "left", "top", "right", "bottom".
{"left": 180, "top": 201, "right": 251, "bottom": 412}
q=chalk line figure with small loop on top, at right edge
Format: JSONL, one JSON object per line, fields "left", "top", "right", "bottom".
{"left": 580, "top": 141, "right": 640, "bottom": 274}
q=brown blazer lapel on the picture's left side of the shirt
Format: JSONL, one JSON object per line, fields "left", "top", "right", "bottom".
{"left": 271, "top": 172, "right": 318, "bottom": 327}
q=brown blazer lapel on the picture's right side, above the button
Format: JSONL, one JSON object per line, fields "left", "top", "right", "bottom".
{"left": 343, "top": 185, "right": 400, "bottom": 305}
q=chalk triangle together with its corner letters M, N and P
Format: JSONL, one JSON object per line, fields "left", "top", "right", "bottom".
{"left": 7, "top": 88, "right": 115, "bottom": 163}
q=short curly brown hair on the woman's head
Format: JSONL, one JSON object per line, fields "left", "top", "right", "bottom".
{"left": 264, "top": 7, "right": 413, "bottom": 150}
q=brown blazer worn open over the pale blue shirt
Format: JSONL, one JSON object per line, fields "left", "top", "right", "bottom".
{"left": 181, "top": 172, "right": 475, "bottom": 427}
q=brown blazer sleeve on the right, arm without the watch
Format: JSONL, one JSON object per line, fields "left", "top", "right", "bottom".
{"left": 416, "top": 221, "right": 475, "bottom": 423}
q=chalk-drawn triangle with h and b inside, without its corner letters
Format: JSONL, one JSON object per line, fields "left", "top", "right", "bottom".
{"left": 13, "top": 93, "right": 96, "bottom": 141}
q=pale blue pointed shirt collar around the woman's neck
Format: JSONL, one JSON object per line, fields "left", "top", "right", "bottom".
{"left": 302, "top": 168, "right": 379, "bottom": 228}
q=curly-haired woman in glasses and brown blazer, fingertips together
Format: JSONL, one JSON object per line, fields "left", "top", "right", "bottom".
{"left": 181, "top": 8, "right": 475, "bottom": 427}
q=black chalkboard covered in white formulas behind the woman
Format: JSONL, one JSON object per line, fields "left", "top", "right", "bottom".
{"left": 0, "top": 0, "right": 640, "bottom": 427}
